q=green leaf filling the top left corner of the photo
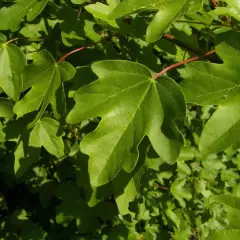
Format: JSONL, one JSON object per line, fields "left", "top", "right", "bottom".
{"left": 0, "top": 0, "right": 49, "bottom": 31}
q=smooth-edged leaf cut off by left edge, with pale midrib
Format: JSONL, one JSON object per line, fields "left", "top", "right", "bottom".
{"left": 0, "top": 43, "right": 27, "bottom": 101}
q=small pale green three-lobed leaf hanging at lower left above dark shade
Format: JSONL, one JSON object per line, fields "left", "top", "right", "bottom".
{"left": 29, "top": 118, "right": 64, "bottom": 158}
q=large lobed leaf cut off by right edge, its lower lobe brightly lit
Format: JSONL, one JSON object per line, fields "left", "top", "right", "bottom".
{"left": 181, "top": 32, "right": 240, "bottom": 152}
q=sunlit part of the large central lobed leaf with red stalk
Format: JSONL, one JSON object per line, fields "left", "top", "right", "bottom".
{"left": 67, "top": 61, "right": 184, "bottom": 186}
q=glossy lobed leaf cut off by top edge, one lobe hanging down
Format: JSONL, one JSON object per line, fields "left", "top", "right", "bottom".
{"left": 109, "top": 0, "right": 202, "bottom": 42}
